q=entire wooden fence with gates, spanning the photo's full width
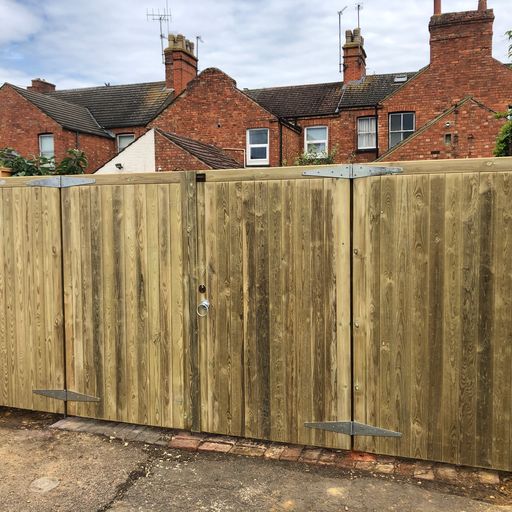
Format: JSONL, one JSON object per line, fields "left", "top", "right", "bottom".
{"left": 0, "top": 159, "right": 512, "bottom": 470}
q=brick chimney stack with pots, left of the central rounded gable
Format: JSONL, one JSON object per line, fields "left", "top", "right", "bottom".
{"left": 164, "top": 34, "right": 197, "bottom": 96}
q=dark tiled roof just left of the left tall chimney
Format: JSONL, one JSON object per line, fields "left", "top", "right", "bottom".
{"left": 47, "top": 82, "right": 174, "bottom": 129}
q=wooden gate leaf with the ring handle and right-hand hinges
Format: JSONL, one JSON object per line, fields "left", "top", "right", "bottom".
{"left": 198, "top": 170, "right": 351, "bottom": 448}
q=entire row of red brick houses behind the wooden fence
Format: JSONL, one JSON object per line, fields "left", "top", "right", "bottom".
{"left": 0, "top": 0, "right": 512, "bottom": 172}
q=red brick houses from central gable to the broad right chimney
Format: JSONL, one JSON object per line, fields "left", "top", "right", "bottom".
{"left": 146, "top": 0, "right": 512, "bottom": 166}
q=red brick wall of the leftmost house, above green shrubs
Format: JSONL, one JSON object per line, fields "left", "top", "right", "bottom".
{"left": 0, "top": 85, "right": 115, "bottom": 172}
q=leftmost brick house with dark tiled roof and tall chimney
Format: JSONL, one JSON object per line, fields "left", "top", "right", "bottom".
{"left": 0, "top": 36, "right": 197, "bottom": 172}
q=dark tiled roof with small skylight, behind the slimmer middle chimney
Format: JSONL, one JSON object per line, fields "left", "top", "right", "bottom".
{"left": 245, "top": 73, "right": 416, "bottom": 119}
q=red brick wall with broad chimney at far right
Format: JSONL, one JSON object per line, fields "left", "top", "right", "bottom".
{"left": 379, "top": 11, "right": 512, "bottom": 158}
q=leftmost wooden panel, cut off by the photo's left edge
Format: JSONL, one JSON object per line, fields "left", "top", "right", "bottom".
{"left": 0, "top": 179, "right": 64, "bottom": 412}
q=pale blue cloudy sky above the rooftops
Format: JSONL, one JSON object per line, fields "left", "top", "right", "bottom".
{"left": 0, "top": 0, "right": 512, "bottom": 89}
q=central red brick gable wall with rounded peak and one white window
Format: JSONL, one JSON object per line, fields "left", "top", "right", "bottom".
{"left": 150, "top": 68, "right": 284, "bottom": 166}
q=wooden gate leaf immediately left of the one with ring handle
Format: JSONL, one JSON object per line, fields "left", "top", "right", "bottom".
{"left": 62, "top": 173, "right": 197, "bottom": 428}
